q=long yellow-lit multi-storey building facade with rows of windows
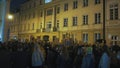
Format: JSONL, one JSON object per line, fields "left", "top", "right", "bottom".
{"left": 10, "top": 0, "right": 120, "bottom": 44}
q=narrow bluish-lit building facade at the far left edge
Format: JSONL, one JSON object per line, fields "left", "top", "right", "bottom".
{"left": 0, "top": 0, "right": 10, "bottom": 41}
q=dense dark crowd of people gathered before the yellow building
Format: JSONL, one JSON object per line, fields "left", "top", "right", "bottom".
{"left": 0, "top": 39, "right": 120, "bottom": 68}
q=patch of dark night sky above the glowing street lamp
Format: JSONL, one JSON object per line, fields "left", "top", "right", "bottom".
{"left": 10, "top": 0, "right": 26, "bottom": 11}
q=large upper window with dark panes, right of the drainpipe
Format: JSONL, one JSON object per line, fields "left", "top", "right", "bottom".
{"left": 110, "top": 4, "right": 119, "bottom": 20}
